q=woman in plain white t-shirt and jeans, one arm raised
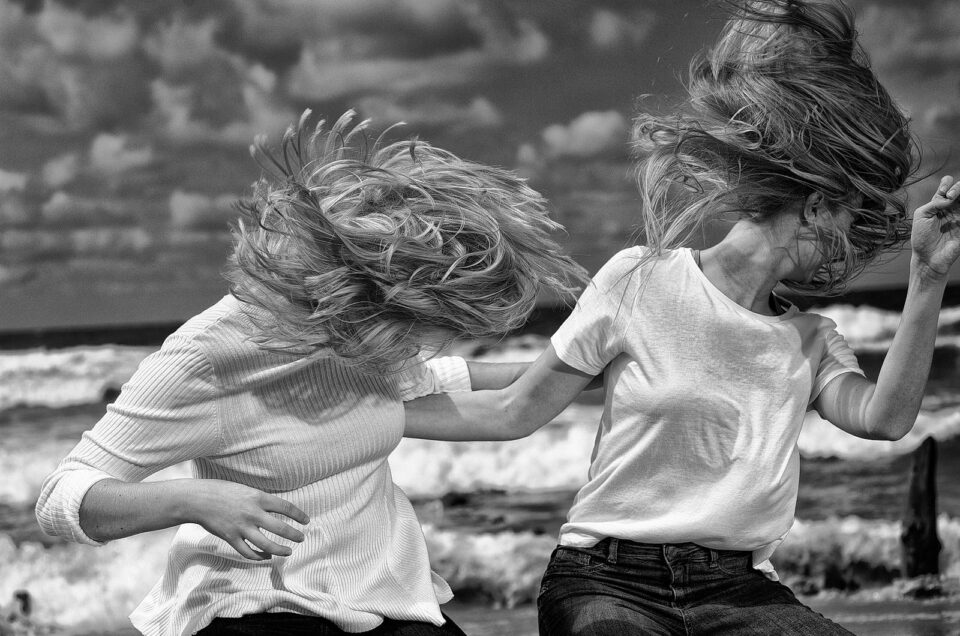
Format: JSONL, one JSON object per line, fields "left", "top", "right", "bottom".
{"left": 406, "top": 0, "right": 960, "bottom": 636}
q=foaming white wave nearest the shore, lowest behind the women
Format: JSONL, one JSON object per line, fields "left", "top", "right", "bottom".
{"left": 0, "top": 516, "right": 960, "bottom": 631}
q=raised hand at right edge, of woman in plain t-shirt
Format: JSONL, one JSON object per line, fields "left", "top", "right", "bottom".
{"left": 910, "top": 176, "right": 960, "bottom": 278}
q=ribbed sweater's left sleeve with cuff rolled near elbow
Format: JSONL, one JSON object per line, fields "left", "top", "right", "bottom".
{"left": 36, "top": 334, "right": 220, "bottom": 545}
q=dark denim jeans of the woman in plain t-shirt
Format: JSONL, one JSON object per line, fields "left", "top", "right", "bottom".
{"left": 537, "top": 539, "right": 851, "bottom": 636}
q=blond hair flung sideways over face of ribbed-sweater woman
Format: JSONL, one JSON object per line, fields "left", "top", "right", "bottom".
{"left": 226, "top": 111, "right": 586, "bottom": 371}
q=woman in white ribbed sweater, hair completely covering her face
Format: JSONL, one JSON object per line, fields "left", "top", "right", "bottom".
{"left": 37, "top": 113, "right": 582, "bottom": 636}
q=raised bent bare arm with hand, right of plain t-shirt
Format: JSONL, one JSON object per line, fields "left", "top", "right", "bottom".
{"left": 814, "top": 177, "right": 960, "bottom": 440}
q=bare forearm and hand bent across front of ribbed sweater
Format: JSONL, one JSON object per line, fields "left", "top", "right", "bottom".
{"left": 80, "top": 479, "right": 310, "bottom": 561}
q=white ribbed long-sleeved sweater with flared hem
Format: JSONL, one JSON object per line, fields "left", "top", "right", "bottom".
{"left": 37, "top": 296, "right": 470, "bottom": 636}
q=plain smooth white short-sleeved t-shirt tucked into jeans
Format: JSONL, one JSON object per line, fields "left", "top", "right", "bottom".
{"left": 552, "top": 247, "right": 863, "bottom": 577}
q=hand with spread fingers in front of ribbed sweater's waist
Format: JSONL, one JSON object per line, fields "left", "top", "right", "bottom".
{"left": 185, "top": 479, "right": 310, "bottom": 561}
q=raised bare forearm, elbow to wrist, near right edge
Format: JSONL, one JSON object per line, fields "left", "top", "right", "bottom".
{"left": 864, "top": 263, "right": 947, "bottom": 439}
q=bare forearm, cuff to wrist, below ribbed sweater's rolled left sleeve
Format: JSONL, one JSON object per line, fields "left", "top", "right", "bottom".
{"left": 80, "top": 479, "right": 200, "bottom": 541}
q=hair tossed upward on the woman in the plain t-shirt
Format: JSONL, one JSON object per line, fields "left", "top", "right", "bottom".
{"left": 633, "top": 0, "right": 916, "bottom": 293}
